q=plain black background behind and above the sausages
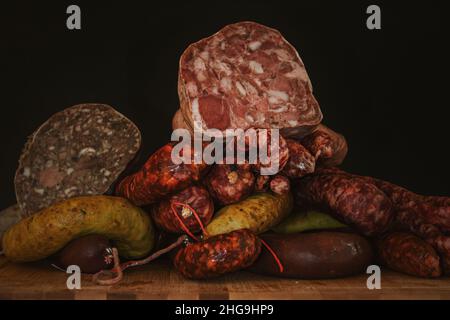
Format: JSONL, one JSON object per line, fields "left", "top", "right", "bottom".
{"left": 0, "top": 0, "right": 450, "bottom": 207}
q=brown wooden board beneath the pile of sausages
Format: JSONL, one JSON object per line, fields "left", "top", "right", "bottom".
{"left": 0, "top": 258, "right": 450, "bottom": 300}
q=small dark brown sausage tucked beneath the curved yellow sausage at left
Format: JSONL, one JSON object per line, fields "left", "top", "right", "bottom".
{"left": 53, "top": 234, "right": 114, "bottom": 273}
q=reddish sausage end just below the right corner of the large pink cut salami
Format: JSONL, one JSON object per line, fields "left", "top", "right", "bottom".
{"left": 301, "top": 124, "right": 348, "bottom": 167}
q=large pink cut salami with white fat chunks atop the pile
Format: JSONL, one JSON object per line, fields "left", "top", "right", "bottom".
{"left": 178, "top": 22, "right": 322, "bottom": 136}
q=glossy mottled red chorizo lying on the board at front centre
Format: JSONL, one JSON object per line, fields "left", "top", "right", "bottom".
{"left": 174, "top": 229, "right": 261, "bottom": 279}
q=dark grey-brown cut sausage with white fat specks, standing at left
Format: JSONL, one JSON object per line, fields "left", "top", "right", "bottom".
{"left": 14, "top": 104, "right": 141, "bottom": 215}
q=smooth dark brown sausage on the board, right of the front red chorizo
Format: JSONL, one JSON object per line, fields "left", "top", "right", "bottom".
{"left": 248, "top": 231, "right": 373, "bottom": 279}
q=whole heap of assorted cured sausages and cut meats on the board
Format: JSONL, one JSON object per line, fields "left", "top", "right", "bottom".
{"left": 0, "top": 22, "right": 450, "bottom": 285}
